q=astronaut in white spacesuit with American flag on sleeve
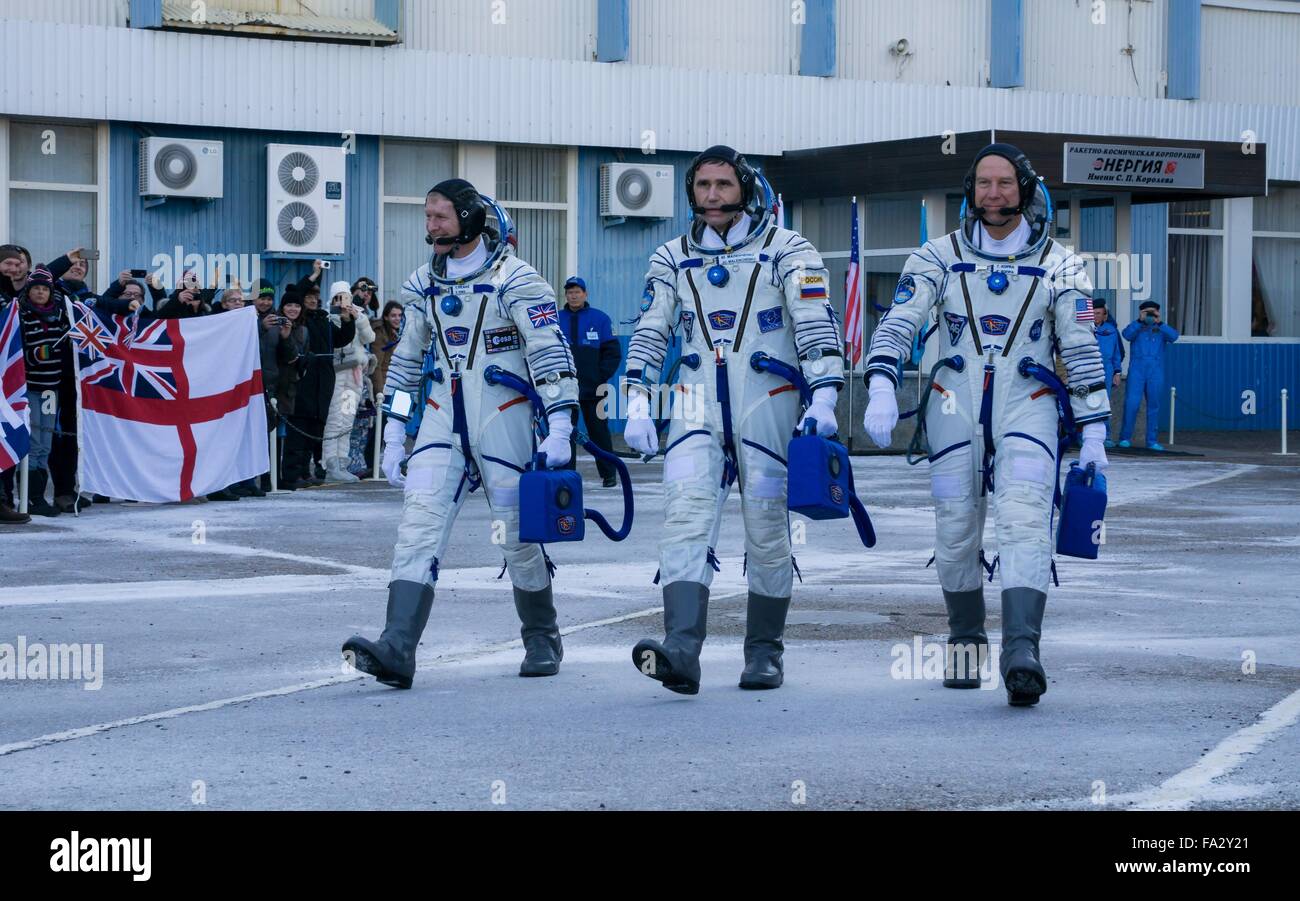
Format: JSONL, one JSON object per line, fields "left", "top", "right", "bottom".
{"left": 863, "top": 144, "right": 1110, "bottom": 706}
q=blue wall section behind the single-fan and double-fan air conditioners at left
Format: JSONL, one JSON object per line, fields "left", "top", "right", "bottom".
{"left": 109, "top": 122, "right": 382, "bottom": 301}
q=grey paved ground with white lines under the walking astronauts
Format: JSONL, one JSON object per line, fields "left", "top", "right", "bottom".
{"left": 0, "top": 456, "right": 1300, "bottom": 810}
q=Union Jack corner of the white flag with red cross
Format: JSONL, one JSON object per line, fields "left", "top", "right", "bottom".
{"left": 73, "top": 304, "right": 178, "bottom": 400}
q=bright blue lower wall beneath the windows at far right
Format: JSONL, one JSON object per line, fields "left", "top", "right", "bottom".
{"left": 1160, "top": 342, "right": 1300, "bottom": 437}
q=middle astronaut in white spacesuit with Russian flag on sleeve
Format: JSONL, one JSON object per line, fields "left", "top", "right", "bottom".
{"left": 624, "top": 146, "right": 844, "bottom": 694}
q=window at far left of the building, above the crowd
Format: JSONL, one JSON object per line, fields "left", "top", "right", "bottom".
{"left": 0, "top": 121, "right": 99, "bottom": 290}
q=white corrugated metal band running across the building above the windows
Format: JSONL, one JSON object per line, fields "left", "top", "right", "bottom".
{"left": 0, "top": 21, "right": 1300, "bottom": 181}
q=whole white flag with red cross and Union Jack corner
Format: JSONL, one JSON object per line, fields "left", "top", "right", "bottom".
{"left": 69, "top": 303, "right": 270, "bottom": 503}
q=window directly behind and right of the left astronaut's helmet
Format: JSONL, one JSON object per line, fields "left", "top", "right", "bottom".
{"left": 497, "top": 146, "right": 569, "bottom": 294}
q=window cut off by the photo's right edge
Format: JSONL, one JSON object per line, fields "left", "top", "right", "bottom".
{"left": 1251, "top": 187, "right": 1300, "bottom": 338}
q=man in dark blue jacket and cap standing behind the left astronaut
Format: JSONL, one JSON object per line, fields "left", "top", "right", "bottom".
{"left": 560, "top": 276, "right": 623, "bottom": 488}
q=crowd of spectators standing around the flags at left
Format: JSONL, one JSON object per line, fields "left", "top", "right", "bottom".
{"left": 0, "top": 244, "right": 402, "bottom": 524}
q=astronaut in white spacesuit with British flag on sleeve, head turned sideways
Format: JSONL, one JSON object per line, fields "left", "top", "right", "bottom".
{"left": 343, "top": 178, "right": 577, "bottom": 688}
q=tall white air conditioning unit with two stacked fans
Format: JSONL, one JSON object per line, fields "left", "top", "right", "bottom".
{"left": 267, "top": 144, "right": 347, "bottom": 255}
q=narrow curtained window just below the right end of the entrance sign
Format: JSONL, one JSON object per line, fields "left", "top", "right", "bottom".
{"left": 1165, "top": 200, "right": 1223, "bottom": 338}
